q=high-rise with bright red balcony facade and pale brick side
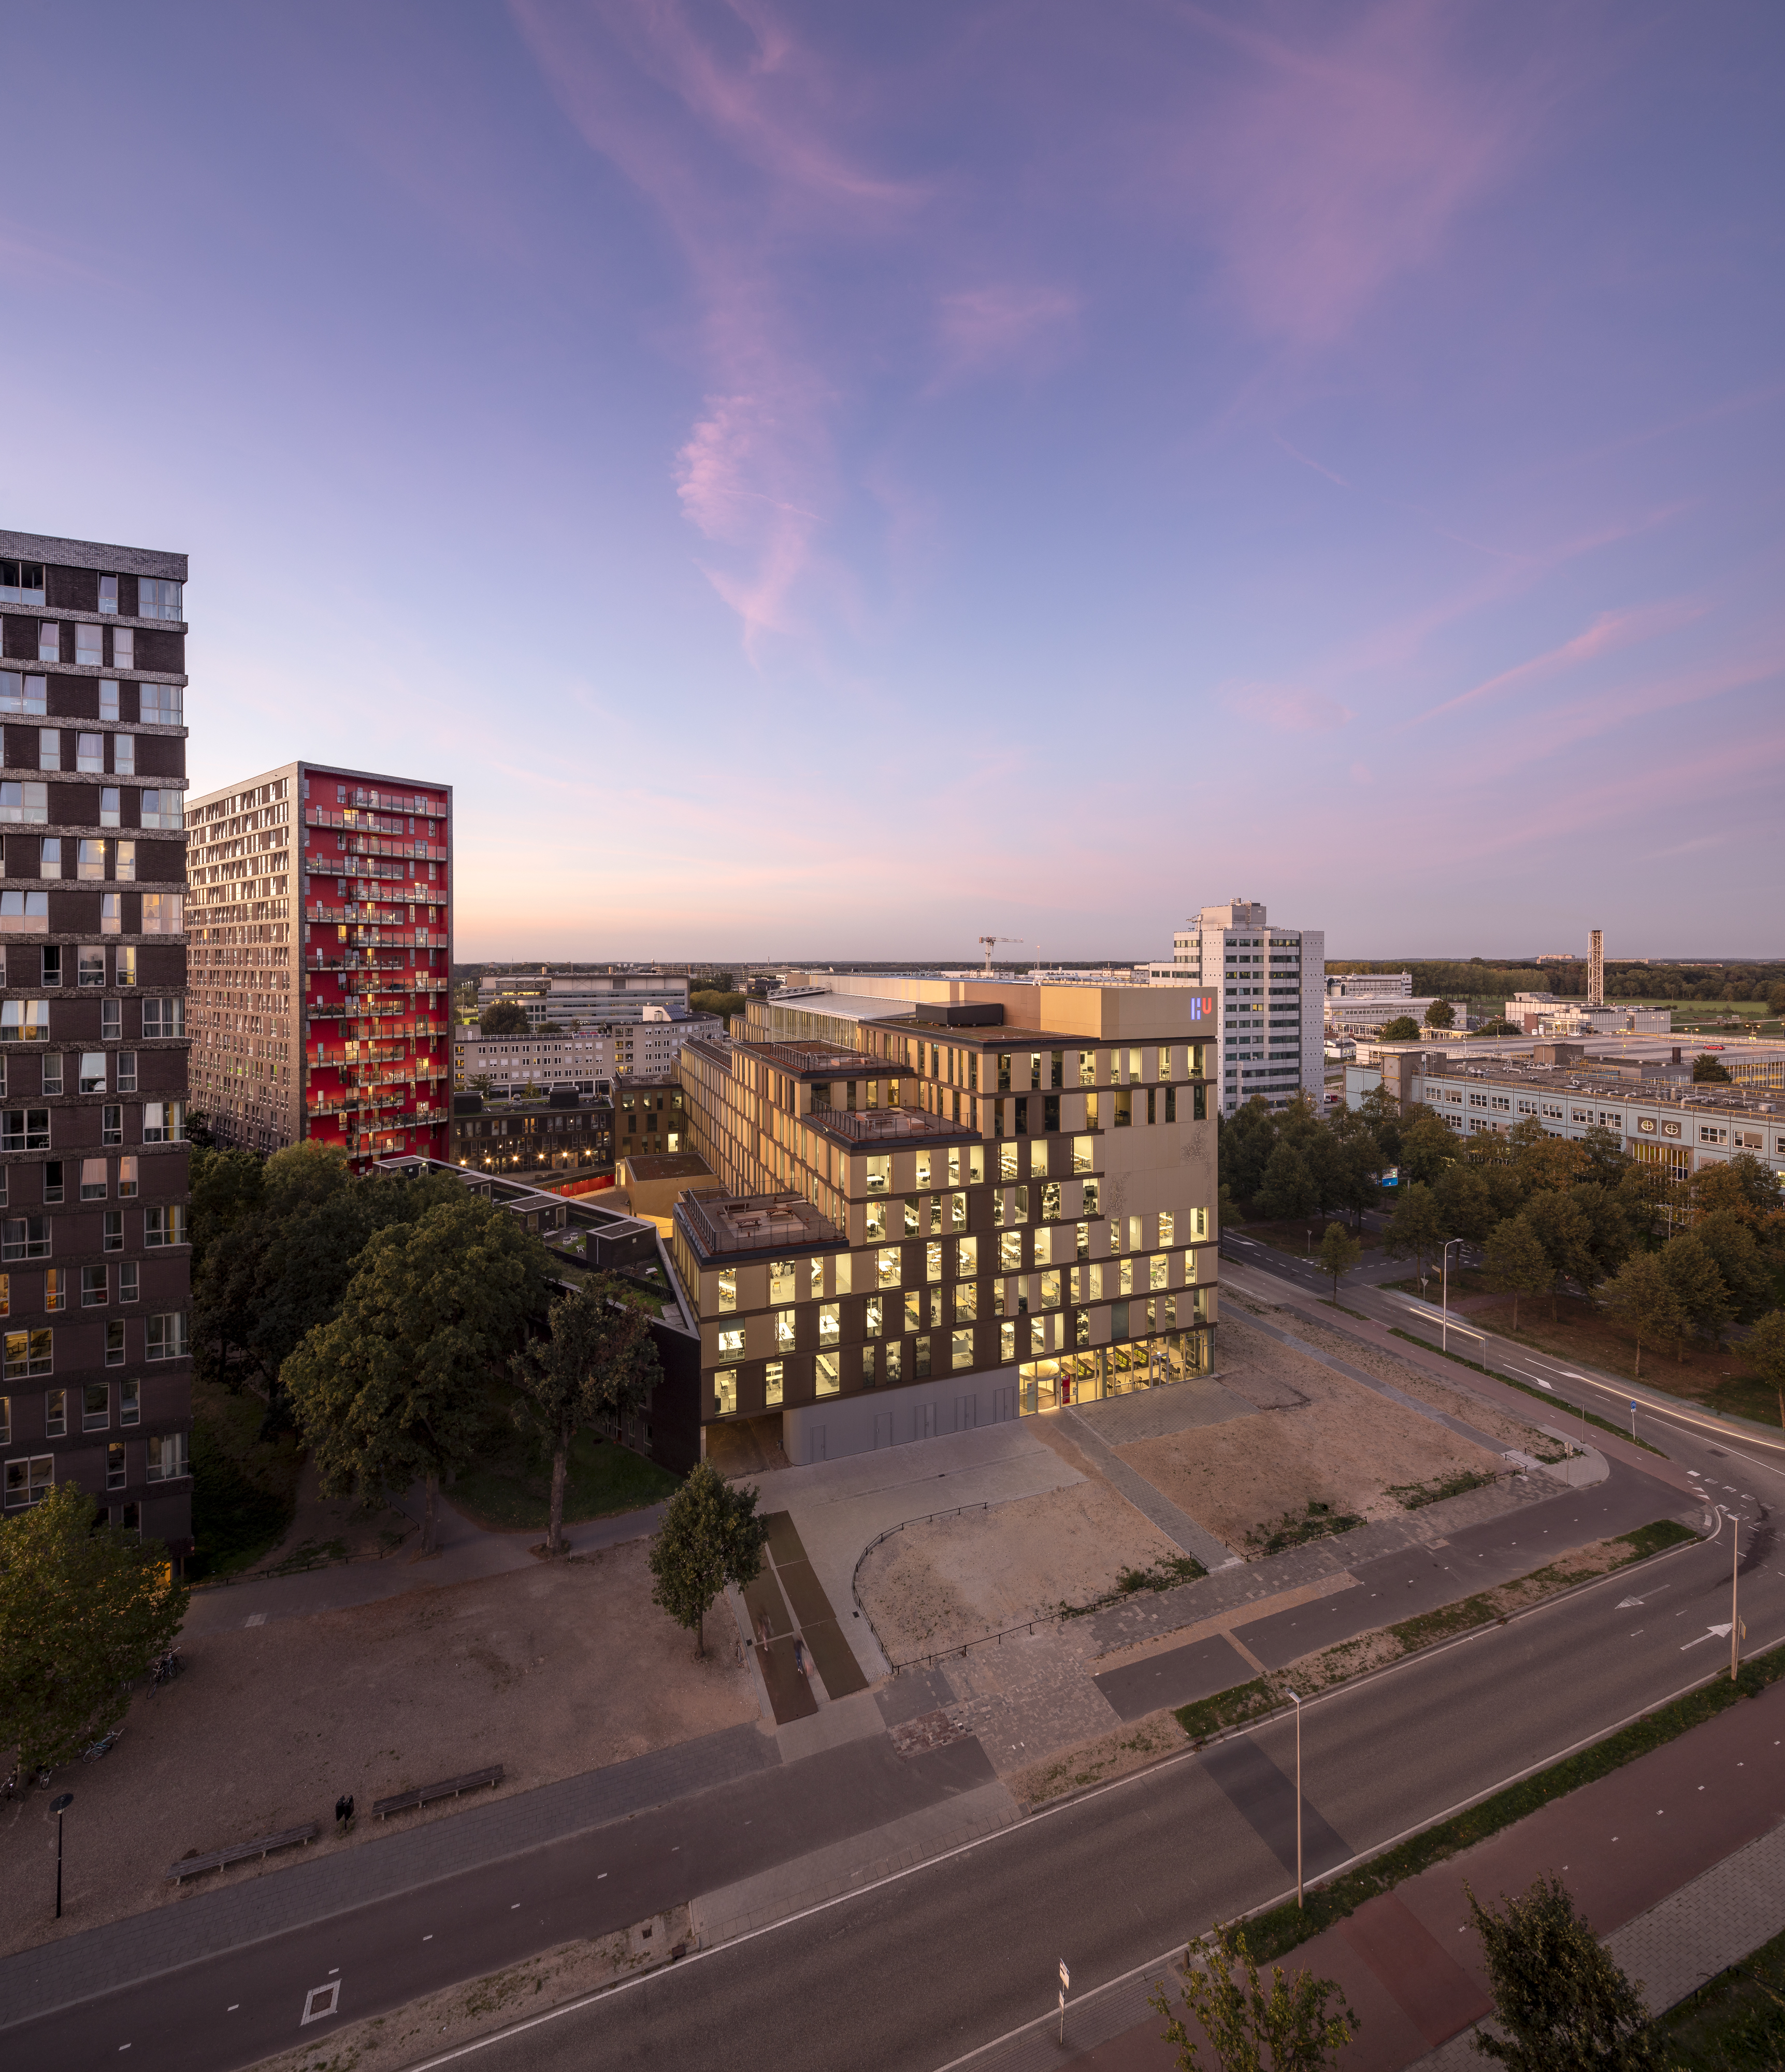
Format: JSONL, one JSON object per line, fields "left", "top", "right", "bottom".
{"left": 189, "top": 762, "right": 451, "bottom": 1173}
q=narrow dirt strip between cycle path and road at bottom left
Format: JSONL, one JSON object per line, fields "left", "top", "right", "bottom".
{"left": 257, "top": 1906, "right": 694, "bottom": 2072}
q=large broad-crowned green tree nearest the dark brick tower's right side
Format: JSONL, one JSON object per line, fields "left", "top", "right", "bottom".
{"left": 280, "top": 1191, "right": 551, "bottom": 1554}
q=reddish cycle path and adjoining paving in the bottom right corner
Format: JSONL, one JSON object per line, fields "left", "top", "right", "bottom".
{"left": 977, "top": 1685, "right": 1785, "bottom": 2072}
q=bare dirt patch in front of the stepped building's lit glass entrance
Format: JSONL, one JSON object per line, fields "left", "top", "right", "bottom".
{"left": 1120, "top": 1307, "right": 1534, "bottom": 1548}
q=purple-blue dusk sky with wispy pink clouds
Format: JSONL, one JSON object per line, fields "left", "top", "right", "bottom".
{"left": 0, "top": 0, "right": 1785, "bottom": 961}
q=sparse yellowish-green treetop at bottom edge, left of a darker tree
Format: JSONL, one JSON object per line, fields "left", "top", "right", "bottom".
{"left": 1147, "top": 1923, "right": 1362, "bottom": 2072}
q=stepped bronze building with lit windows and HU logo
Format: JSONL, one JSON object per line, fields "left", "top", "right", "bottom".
{"left": 673, "top": 974, "right": 1218, "bottom": 1461}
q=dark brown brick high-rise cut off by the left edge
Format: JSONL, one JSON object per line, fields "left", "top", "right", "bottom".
{"left": 0, "top": 533, "right": 193, "bottom": 1554}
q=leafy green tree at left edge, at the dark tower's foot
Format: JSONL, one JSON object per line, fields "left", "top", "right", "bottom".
{"left": 0, "top": 1481, "right": 193, "bottom": 1776}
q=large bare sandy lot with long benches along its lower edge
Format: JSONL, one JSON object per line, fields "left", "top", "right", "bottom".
{"left": 0, "top": 1542, "right": 758, "bottom": 1950}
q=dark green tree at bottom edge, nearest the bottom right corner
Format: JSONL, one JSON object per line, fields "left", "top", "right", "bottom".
{"left": 1464, "top": 1875, "right": 1661, "bottom": 2072}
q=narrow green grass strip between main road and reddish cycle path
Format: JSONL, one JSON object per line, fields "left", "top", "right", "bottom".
{"left": 1234, "top": 1649, "right": 1785, "bottom": 1964}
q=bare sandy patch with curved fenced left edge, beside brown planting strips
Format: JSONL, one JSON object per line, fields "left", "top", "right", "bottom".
{"left": 855, "top": 1479, "right": 1181, "bottom": 1662}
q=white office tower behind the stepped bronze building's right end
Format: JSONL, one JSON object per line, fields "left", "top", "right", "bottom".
{"left": 1149, "top": 899, "right": 1328, "bottom": 1115}
